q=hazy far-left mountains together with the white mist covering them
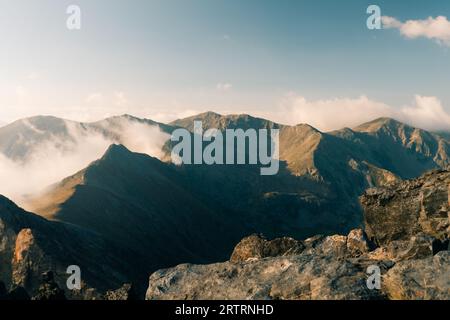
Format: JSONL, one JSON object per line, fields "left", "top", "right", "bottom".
{"left": 0, "top": 115, "right": 169, "bottom": 202}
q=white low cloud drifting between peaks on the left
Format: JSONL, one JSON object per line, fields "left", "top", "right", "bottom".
{"left": 0, "top": 119, "right": 169, "bottom": 204}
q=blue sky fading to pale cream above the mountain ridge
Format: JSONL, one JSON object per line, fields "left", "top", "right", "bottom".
{"left": 0, "top": 0, "right": 450, "bottom": 130}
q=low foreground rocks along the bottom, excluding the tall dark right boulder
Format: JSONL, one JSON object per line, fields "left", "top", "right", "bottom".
{"left": 146, "top": 230, "right": 450, "bottom": 300}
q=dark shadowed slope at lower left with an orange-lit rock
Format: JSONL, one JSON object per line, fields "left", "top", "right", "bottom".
{"left": 0, "top": 196, "right": 142, "bottom": 298}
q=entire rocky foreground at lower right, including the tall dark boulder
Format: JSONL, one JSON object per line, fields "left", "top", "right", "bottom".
{"left": 146, "top": 170, "right": 450, "bottom": 299}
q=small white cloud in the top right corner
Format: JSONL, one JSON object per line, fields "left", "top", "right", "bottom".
{"left": 382, "top": 16, "right": 450, "bottom": 46}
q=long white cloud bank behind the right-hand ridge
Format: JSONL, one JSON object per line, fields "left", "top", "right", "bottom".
{"left": 262, "top": 93, "right": 450, "bottom": 131}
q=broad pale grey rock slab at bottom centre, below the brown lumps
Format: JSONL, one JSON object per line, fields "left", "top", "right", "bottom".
{"left": 146, "top": 254, "right": 383, "bottom": 300}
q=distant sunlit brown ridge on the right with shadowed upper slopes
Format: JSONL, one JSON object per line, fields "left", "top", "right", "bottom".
{"left": 171, "top": 112, "right": 450, "bottom": 179}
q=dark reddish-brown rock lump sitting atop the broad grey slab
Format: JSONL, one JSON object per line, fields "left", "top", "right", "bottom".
{"left": 230, "top": 235, "right": 305, "bottom": 263}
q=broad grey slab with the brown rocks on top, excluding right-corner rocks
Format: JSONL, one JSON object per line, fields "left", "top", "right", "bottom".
{"left": 147, "top": 230, "right": 385, "bottom": 299}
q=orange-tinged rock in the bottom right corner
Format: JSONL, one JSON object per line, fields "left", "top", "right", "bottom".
{"left": 382, "top": 251, "right": 450, "bottom": 300}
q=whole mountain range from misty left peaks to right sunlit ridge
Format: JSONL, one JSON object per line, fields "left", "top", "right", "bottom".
{"left": 0, "top": 112, "right": 450, "bottom": 297}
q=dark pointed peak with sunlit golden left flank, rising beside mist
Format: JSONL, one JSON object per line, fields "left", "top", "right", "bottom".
{"left": 22, "top": 145, "right": 245, "bottom": 270}
